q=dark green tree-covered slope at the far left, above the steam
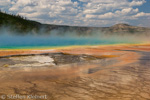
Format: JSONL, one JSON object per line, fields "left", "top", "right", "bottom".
{"left": 0, "top": 11, "right": 41, "bottom": 33}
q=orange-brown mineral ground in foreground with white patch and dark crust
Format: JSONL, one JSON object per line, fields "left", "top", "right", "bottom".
{"left": 0, "top": 45, "right": 150, "bottom": 100}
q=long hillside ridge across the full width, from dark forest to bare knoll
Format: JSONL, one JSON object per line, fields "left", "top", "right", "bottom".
{"left": 0, "top": 12, "right": 150, "bottom": 35}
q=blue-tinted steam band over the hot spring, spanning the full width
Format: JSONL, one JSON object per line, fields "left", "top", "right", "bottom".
{"left": 0, "top": 27, "right": 150, "bottom": 48}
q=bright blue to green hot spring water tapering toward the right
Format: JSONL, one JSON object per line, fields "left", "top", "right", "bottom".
{"left": 0, "top": 34, "right": 135, "bottom": 49}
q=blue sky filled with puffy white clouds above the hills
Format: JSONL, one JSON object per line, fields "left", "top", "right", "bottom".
{"left": 0, "top": 0, "right": 150, "bottom": 27}
